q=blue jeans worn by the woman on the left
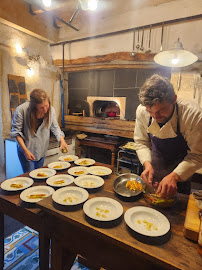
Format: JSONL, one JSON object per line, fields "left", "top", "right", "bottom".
{"left": 17, "top": 145, "right": 45, "bottom": 173}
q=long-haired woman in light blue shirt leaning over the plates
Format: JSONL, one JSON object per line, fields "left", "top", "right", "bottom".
{"left": 10, "top": 89, "right": 68, "bottom": 173}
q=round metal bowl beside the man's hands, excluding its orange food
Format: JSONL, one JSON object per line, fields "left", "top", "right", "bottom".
{"left": 113, "top": 173, "right": 145, "bottom": 197}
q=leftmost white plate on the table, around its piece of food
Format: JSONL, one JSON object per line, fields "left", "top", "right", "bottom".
{"left": 1, "top": 177, "right": 34, "bottom": 191}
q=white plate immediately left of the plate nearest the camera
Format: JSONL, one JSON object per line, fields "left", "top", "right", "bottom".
{"left": 83, "top": 197, "right": 123, "bottom": 221}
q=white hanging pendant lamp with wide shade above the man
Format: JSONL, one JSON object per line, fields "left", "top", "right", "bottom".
{"left": 154, "top": 38, "right": 198, "bottom": 67}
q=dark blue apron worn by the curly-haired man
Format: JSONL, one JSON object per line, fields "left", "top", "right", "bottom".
{"left": 148, "top": 104, "right": 191, "bottom": 194}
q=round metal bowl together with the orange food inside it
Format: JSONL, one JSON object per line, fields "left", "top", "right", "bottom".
{"left": 113, "top": 173, "right": 145, "bottom": 197}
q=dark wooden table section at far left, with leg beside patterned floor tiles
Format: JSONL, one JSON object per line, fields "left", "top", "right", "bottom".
{"left": 0, "top": 173, "right": 50, "bottom": 270}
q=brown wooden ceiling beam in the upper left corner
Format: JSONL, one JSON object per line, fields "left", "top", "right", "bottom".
{"left": 0, "top": 0, "right": 59, "bottom": 43}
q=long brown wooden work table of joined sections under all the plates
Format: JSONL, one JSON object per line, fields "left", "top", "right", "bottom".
{"left": 0, "top": 163, "right": 202, "bottom": 270}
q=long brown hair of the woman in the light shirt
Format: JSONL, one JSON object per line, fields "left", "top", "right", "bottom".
{"left": 29, "top": 89, "right": 51, "bottom": 135}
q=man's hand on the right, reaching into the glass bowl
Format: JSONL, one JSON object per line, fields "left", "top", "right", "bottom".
{"left": 156, "top": 172, "right": 180, "bottom": 197}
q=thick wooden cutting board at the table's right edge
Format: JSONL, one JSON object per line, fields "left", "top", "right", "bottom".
{"left": 184, "top": 194, "right": 200, "bottom": 241}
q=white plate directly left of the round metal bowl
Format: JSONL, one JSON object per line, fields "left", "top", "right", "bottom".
{"left": 74, "top": 175, "right": 104, "bottom": 189}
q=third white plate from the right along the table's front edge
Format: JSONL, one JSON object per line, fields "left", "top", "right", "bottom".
{"left": 52, "top": 187, "right": 89, "bottom": 205}
